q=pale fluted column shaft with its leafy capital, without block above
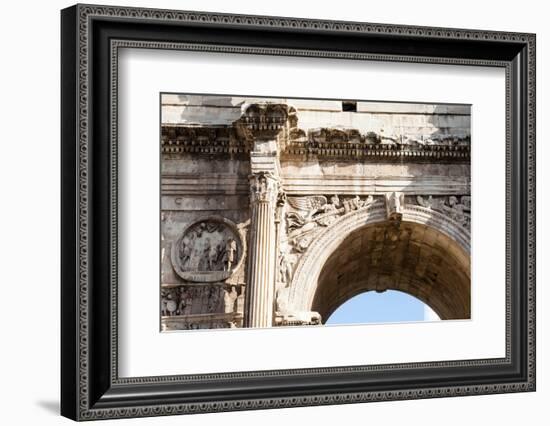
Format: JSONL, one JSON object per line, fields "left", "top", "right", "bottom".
{"left": 245, "top": 172, "right": 279, "bottom": 327}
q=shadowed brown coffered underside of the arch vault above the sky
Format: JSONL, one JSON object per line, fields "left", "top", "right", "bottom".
{"left": 311, "top": 221, "right": 470, "bottom": 323}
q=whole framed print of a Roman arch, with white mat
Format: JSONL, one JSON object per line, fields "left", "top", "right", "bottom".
{"left": 61, "top": 5, "right": 535, "bottom": 420}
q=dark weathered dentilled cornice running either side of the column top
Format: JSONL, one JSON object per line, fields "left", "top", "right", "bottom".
{"left": 161, "top": 125, "right": 470, "bottom": 162}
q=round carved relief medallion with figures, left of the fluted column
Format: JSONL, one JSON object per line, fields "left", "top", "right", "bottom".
{"left": 171, "top": 216, "right": 244, "bottom": 282}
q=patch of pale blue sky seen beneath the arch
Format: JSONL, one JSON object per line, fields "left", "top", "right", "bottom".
{"left": 325, "top": 290, "right": 439, "bottom": 325}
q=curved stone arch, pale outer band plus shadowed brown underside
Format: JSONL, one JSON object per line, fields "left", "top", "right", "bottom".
{"left": 287, "top": 202, "right": 470, "bottom": 320}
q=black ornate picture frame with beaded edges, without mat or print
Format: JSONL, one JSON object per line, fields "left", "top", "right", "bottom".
{"left": 61, "top": 5, "right": 536, "bottom": 420}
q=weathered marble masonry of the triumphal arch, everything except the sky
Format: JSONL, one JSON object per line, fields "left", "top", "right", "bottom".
{"left": 160, "top": 94, "right": 472, "bottom": 331}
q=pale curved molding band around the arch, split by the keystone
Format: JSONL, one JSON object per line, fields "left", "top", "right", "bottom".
{"left": 286, "top": 202, "right": 470, "bottom": 312}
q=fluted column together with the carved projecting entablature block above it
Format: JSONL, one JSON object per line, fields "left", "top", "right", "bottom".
{"left": 240, "top": 103, "right": 288, "bottom": 327}
